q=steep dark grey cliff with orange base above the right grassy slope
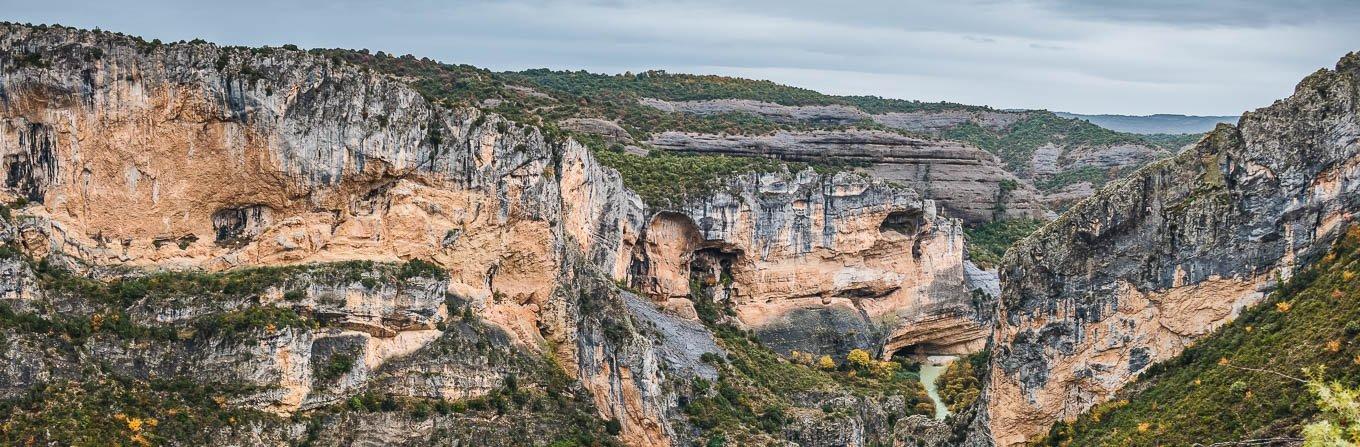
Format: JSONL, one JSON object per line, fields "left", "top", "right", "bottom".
{"left": 982, "top": 54, "right": 1360, "bottom": 446}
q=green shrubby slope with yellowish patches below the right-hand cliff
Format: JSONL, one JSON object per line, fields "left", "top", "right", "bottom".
{"left": 1035, "top": 230, "right": 1360, "bottom": 446}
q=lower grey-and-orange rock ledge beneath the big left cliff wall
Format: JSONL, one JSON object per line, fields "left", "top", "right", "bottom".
{"left": 0, "top": 248, "right": 451, "bottom": 413}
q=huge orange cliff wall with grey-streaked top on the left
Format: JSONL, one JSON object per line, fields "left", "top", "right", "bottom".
{"left": 0, "top": 26, "right": 701, "bottom": 444}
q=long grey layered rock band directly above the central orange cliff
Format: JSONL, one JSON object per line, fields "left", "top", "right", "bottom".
{"left": 649, "top": 130, "right": 1044, "bottom": 223}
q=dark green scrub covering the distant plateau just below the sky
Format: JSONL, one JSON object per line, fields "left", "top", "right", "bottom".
{"left": 313, "top": 49, "right": 1197, "bottom": 198}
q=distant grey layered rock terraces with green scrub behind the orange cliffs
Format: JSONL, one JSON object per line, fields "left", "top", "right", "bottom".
{"left": 639, "top": 98, "right": 1176, "bottom": 210}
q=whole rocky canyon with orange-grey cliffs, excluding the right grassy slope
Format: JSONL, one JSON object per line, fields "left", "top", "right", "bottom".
{"left": 0, "top": 23, "right": 1360, "bottom": 446}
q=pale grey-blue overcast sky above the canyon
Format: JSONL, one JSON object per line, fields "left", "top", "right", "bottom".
{"left": 0, "top": 0, "right": 1360, "bottom": 115}
